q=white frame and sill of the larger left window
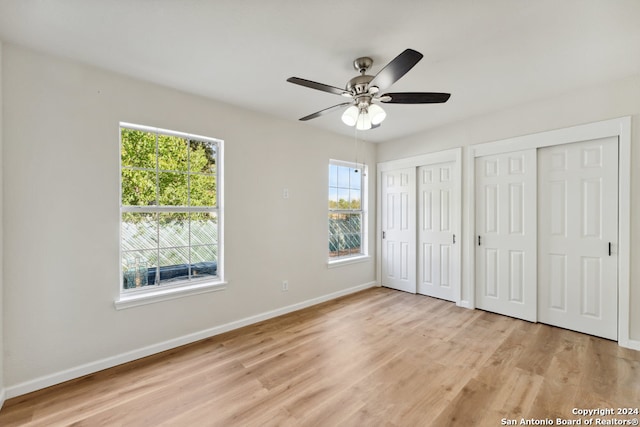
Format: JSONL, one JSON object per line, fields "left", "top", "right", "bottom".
{"left": 114, "top": 122, "right": 226, "bottom": 310}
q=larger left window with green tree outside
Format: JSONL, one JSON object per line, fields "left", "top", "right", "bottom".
{"left": 120, "top": 123, "right": 222, "bottom": 293}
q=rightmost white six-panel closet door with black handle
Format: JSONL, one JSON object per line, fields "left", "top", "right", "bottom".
{"left": 538, "top": 137, "right": 618, "bottom": 340}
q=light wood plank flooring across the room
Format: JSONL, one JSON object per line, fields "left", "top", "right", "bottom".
{"left": 0, "top": 288, "right": 640, "bottom": 427}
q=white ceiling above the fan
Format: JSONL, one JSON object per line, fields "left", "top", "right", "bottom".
{"left": 0, "top": 0, "right": 640, "bottom": 142}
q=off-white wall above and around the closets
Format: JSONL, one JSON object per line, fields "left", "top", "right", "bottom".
{"left": 377, "top": 75, "right": 640, "bottom": 341}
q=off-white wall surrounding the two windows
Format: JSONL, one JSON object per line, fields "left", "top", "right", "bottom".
{"left": 3, "top": 44, "right": 376, "bottom": 395}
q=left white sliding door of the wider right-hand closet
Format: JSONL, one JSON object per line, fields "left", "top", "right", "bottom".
{"left": 475, "top": 149, "right": 537, "bottom": 322}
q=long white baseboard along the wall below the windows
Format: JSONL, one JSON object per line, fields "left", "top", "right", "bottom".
{"left": 5, "top": 281, "right": 378, "bottom": 400}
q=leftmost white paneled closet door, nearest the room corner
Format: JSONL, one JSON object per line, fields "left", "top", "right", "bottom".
{"left": 381, "top": 168, "right": 416, "bottom": 294}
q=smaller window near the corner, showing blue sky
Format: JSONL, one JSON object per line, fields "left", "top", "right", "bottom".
{"left": 329, "top": 160, "right": 367, "bottom": 262}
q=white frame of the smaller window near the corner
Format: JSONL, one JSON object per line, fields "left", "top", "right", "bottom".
{"left": 327, "top": 159, "right": 370, "bottom": 268}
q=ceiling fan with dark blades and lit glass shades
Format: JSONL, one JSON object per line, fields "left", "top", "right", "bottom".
{"left": 287, "top": 49, "right": 451, "bottom": 130}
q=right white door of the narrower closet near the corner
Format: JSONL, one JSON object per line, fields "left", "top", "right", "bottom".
{"left": 418, "top": 162, "right": 460, "bottom": 301}
